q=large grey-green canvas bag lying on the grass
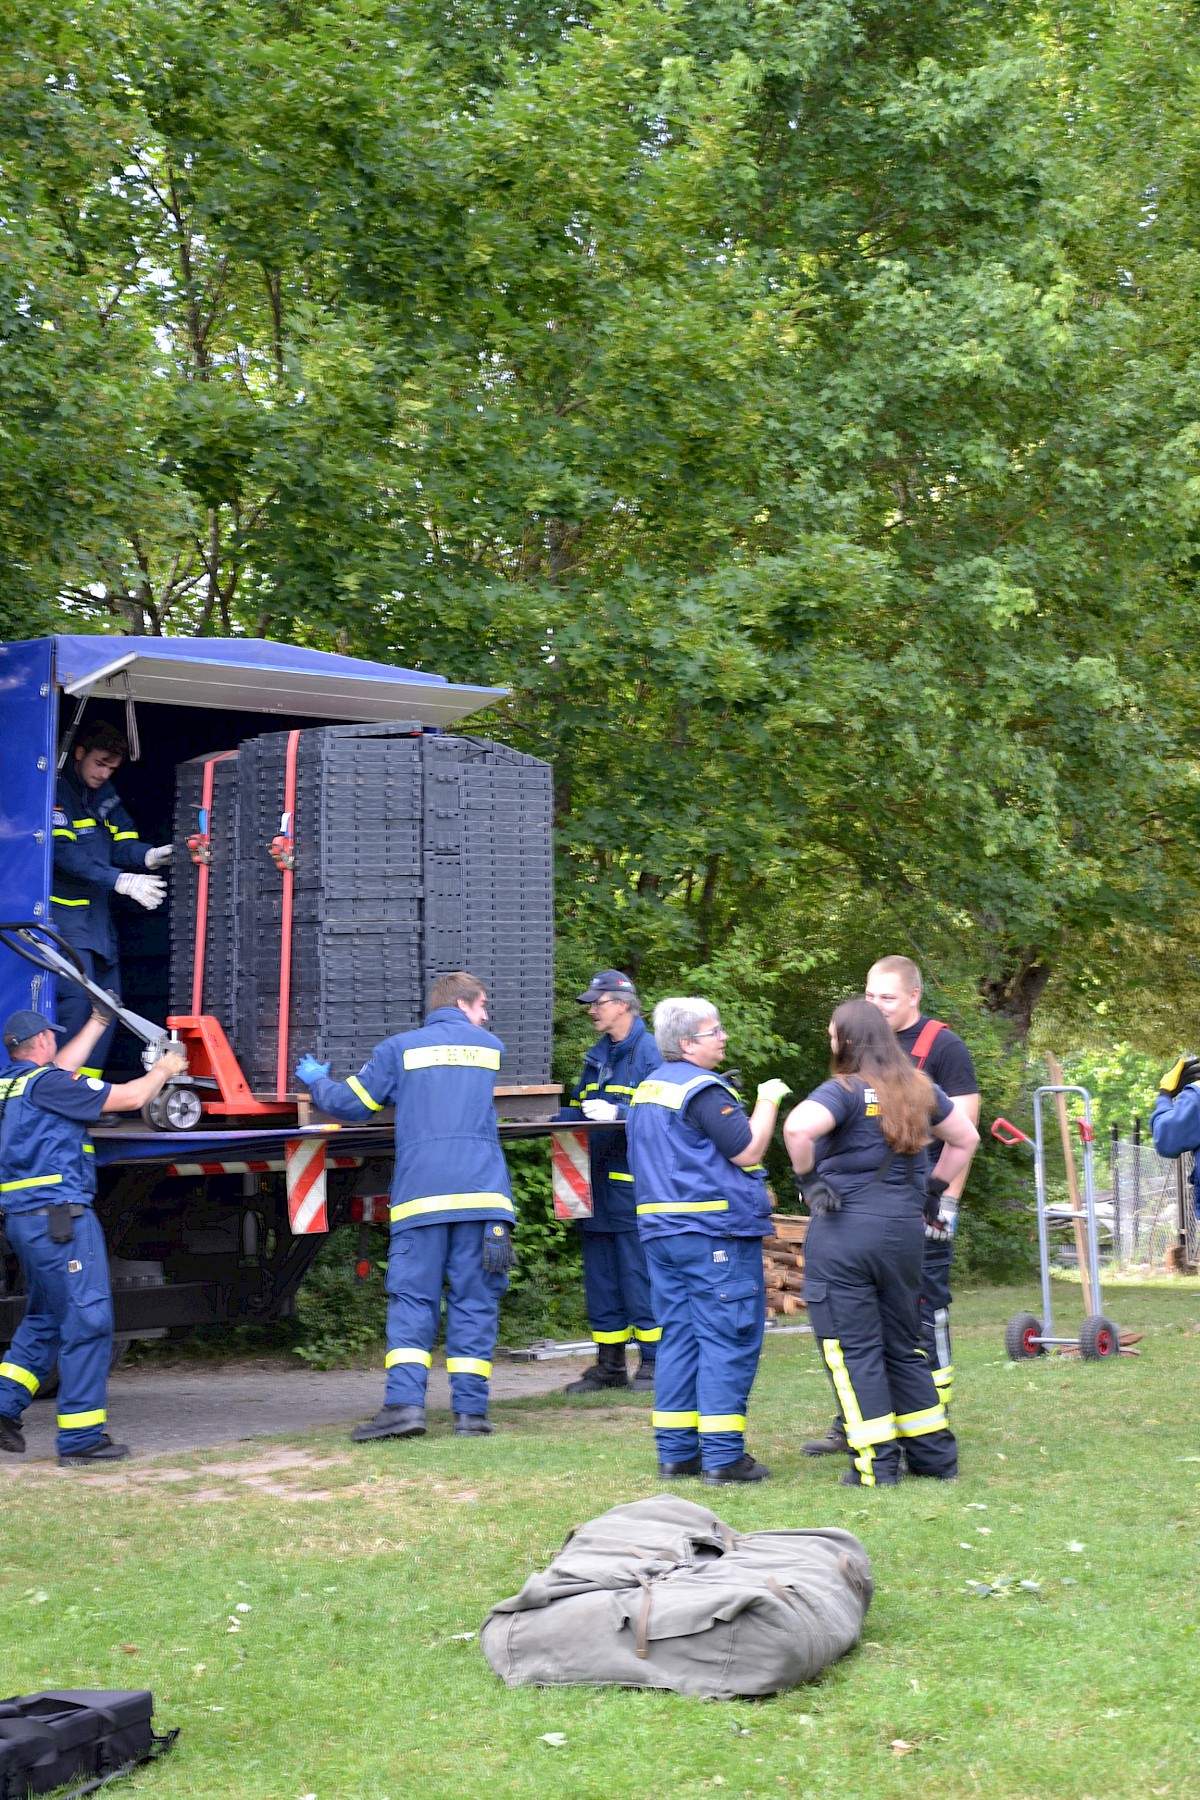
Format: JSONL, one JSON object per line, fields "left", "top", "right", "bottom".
{"left": 480, "top": 1494, "right": 873, "bottom": 1699}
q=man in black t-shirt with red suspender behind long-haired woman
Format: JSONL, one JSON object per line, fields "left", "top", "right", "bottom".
{"left": 802, "top": 956, "right": 979, "bottom": 1456}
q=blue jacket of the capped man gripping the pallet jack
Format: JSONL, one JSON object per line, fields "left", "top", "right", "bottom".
{"left": 0, "top": 1062, "right": 108, "bottom": 1213}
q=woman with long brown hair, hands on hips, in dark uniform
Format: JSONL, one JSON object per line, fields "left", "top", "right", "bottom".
{"left": 783, "top": 999, "right": 979, "bottom": 1487}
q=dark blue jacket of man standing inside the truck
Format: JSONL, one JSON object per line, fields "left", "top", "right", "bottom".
{"left": 50, "top": 769, "right": 153, "bottom": 961}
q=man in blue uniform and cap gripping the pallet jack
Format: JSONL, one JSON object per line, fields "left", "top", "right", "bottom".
{"left": 0, "top": 1012, "right": 187, "bottom": 1465}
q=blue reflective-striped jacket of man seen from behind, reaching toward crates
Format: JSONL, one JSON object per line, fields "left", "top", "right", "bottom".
{"left": 309, "top": 1006, "right": 515, "bottom": 1226}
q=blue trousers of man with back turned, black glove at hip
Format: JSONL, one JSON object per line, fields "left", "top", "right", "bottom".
{"left": 383, "top": 1219, "right": 509, "bottom": 1413}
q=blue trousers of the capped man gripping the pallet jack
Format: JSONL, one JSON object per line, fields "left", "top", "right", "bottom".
{"left": 0, "top": 1206, "right": 113, "bottom": 1456}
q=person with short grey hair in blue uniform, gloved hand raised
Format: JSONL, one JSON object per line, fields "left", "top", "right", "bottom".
{"left": 626, "top": 999, "right": 790, "bottom": 1487}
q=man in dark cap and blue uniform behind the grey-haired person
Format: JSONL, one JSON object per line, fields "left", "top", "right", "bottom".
{"left": 558, "top": 968, "right": 662, "bottom": 1393}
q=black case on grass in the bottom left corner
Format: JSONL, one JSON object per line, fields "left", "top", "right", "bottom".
{"left": 0, "top": 1688, "right": 178, "bottom": 1800}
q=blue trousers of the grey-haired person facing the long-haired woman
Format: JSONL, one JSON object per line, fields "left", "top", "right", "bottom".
{"left": 646, "top": 1231, "right": 766, "bottom": 1469}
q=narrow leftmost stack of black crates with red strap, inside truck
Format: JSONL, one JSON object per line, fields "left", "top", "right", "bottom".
{"left": 171, "top": 754, "right": 239, "bottom": 1042}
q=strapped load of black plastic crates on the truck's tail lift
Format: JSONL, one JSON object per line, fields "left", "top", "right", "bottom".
{"left": 171, "top": 725, "right": 552, "bottom": 1093}
